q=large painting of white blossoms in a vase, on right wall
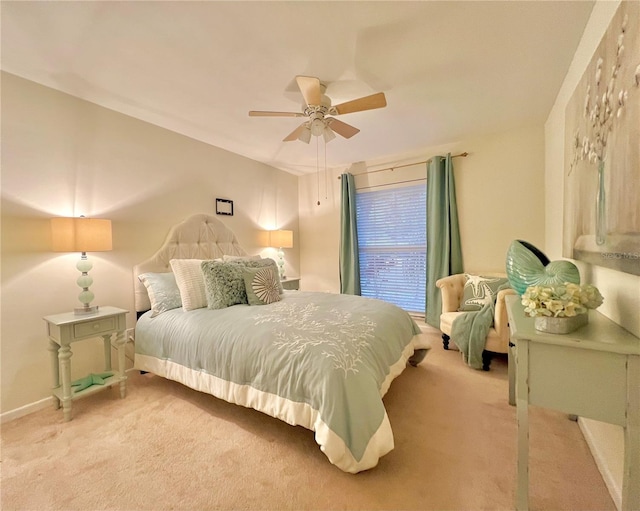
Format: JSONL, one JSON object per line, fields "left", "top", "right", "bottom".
{"left": 562, "top": 1, "right": 640, "bottom": 275}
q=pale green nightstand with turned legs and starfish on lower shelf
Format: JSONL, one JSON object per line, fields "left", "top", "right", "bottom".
{"left": 43, "top": 307, "right": 129, "bottom": 421}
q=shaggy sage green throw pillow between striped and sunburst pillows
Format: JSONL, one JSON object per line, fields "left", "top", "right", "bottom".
{"left": 201, "top": 261, "right": 248, "bottom": 309}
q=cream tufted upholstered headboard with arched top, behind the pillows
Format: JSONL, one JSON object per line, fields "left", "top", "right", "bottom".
{"left": 133, "top": 214, "right": 247, "bottom": 312}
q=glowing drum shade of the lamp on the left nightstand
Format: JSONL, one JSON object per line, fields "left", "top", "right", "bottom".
{"left": 51, "top": 217, "right": 112, "bottom": 252}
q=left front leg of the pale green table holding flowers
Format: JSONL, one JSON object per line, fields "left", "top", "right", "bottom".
{"left": 516, "top": 340, "right": 529, "bottom": 511}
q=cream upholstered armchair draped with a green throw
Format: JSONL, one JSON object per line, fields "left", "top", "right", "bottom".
{"left": 436, "top": 273, "right": 516, "bottom": 371}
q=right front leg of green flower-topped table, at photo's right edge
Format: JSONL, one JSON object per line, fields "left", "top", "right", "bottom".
{"left": 620, "top": 356, "right": 640, "bottom": 511}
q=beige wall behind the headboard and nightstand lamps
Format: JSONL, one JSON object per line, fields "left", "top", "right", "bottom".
{"left": 1, "top": 73, "right": 300, "bottom": 413}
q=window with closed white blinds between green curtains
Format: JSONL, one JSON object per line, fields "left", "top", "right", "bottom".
{"left": 356, "top": 183, "right": 427, "bottom": 314}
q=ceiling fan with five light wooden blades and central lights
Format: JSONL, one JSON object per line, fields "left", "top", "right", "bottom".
{"left": 249, "top": 76, "right": 387, "bottom": 144}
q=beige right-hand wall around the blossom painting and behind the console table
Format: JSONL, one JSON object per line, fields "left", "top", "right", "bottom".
{"left": 545, "top": 1, "right": 640, "bottom": 507}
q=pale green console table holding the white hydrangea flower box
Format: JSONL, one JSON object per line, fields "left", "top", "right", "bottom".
{"left": 507, "top": 296, "right": 640, "bottom": 511}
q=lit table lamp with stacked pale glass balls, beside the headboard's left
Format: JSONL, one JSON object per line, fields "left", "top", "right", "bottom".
{"left": 51, "top": 216, "right": 112, "bottom": 314}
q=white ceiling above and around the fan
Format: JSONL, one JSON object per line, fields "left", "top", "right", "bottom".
{"left": 1, "top": 0, "right": 593, "bottom": 174}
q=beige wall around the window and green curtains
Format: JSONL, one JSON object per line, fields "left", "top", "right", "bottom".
{"left": 299, "top": 125, "right": 544, "bottom": 292}
